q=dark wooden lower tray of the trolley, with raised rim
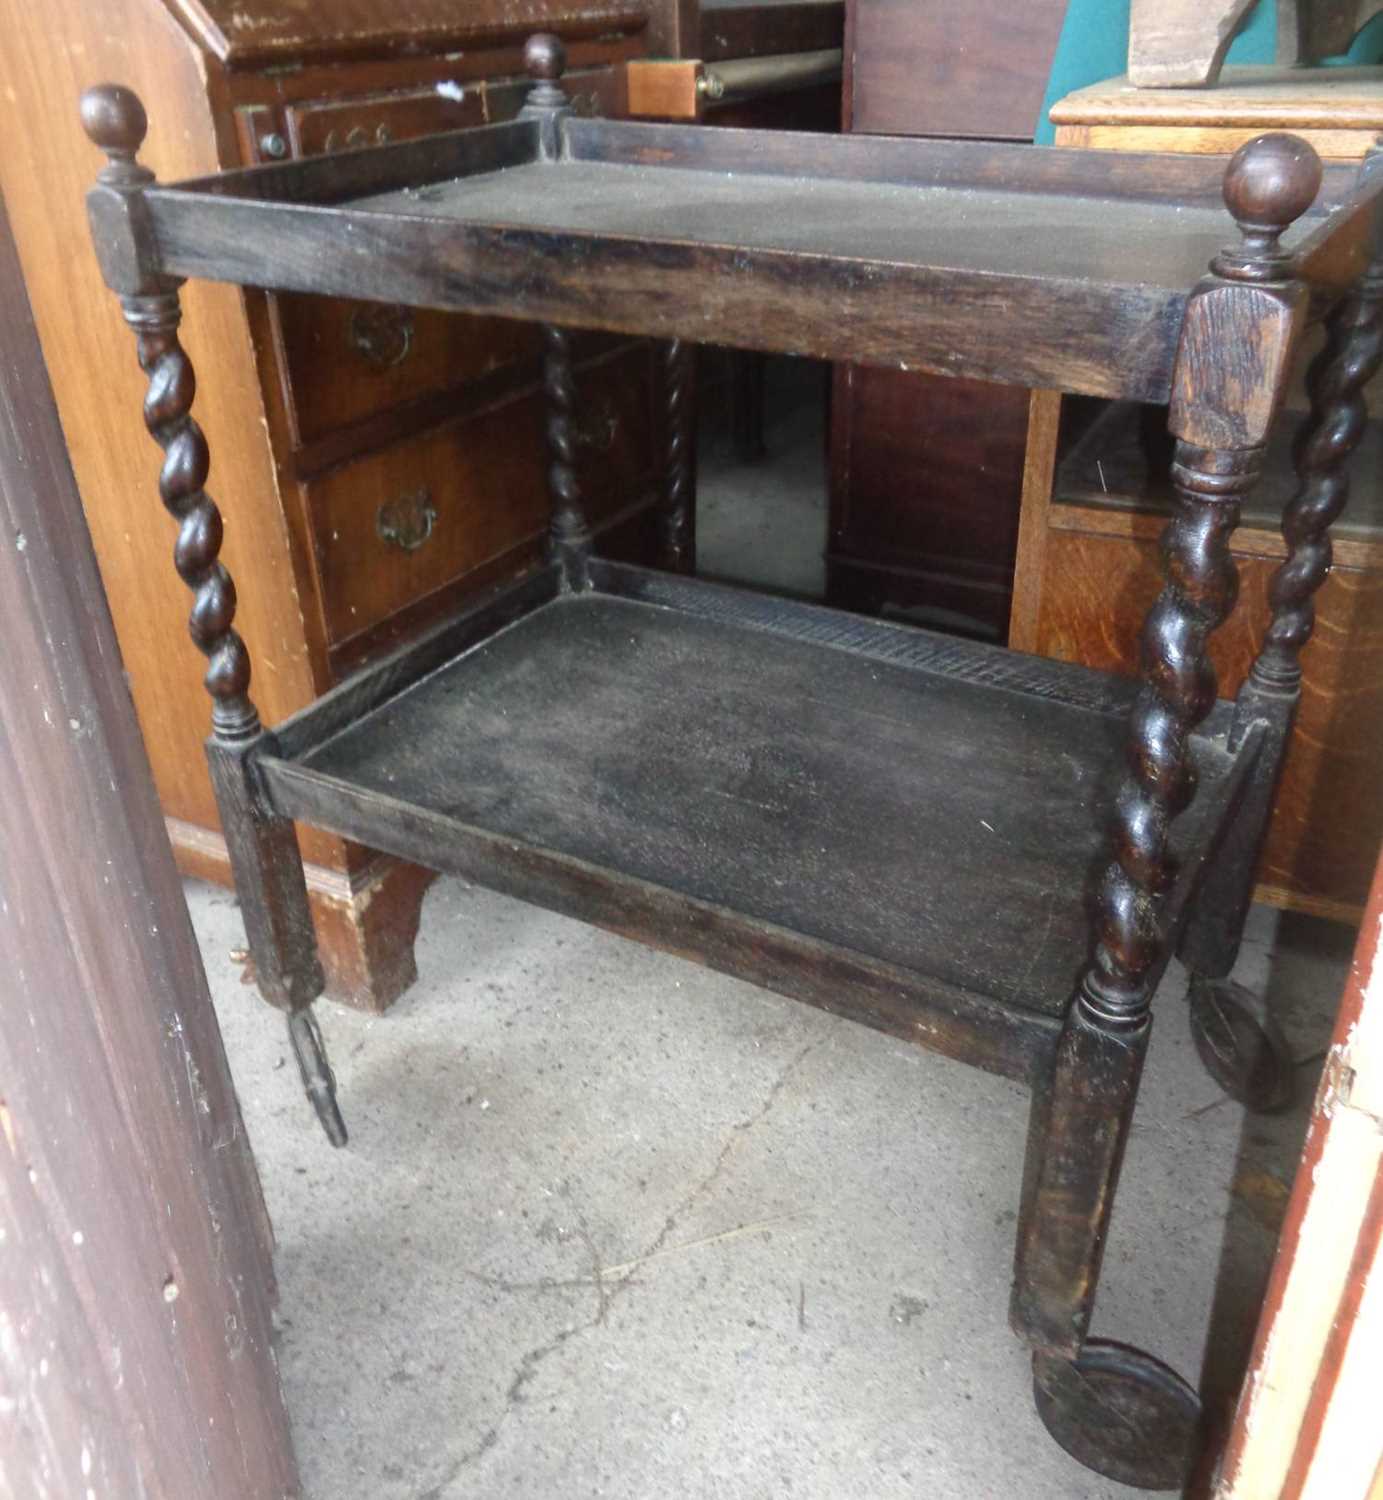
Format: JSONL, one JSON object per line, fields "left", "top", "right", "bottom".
{"left": 261, "top": 561, "right": 1253, "bottom": 1076}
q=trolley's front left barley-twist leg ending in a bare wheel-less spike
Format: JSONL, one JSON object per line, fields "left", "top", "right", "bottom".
{"left": 81, "top": 84, "right": 345, "bottom": 1145}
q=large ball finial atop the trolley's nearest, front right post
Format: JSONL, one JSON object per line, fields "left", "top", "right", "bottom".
{"left": 1214, "top": 131, "right": 1322, "bottom": 281}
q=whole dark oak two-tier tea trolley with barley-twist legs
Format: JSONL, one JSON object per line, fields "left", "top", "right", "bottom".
{"left": 83, "top": 36, "right": 1383, "bottom": 1488}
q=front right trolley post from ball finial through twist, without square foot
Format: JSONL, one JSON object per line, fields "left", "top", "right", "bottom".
{"left": 1077, "top": 135, "right": 1322, "bottom": 1029}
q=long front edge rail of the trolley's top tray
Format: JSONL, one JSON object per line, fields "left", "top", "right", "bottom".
{"left": 147, "top": 196, "right": 1187, "bottom": 402}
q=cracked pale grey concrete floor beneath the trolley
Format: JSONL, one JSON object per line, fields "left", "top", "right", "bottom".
{"left": 188, "top": 366, "right": 1349, "bottom": 1500}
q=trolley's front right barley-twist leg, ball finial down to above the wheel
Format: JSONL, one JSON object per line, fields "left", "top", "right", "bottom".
{"left": 1013, "top": 135, "right": 1322, "bottom": 1356}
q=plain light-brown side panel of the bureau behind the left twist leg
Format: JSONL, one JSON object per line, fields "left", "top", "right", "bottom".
{"left": 0, "top": 0, "right": 318, "bottom": 857}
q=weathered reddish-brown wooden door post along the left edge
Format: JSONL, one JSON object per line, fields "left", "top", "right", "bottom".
{"left": 0, "top": 190, "right": 299, "bottom": 1500}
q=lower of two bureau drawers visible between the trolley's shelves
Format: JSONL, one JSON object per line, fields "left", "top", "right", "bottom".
{"left": 305, "top": 344, "right": 653, "bottom": 645}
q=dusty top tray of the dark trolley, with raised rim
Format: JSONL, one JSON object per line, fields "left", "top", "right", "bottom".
{"left": 123, "top": 116, "right": 1379, "bottom": 401}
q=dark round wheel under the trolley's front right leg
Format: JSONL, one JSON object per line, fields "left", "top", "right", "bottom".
{"left": 1032, "top": 1338, "right": 1200, "bottom": 1491}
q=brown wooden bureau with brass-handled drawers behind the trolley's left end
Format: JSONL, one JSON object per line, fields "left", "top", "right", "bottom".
{"left": 0, "top": 0, "right": 665, "bottom": 1010}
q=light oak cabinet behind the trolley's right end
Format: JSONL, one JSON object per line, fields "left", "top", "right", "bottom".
{"left": 1008, "top": 68, "right": 1383, "bottom": 921}
